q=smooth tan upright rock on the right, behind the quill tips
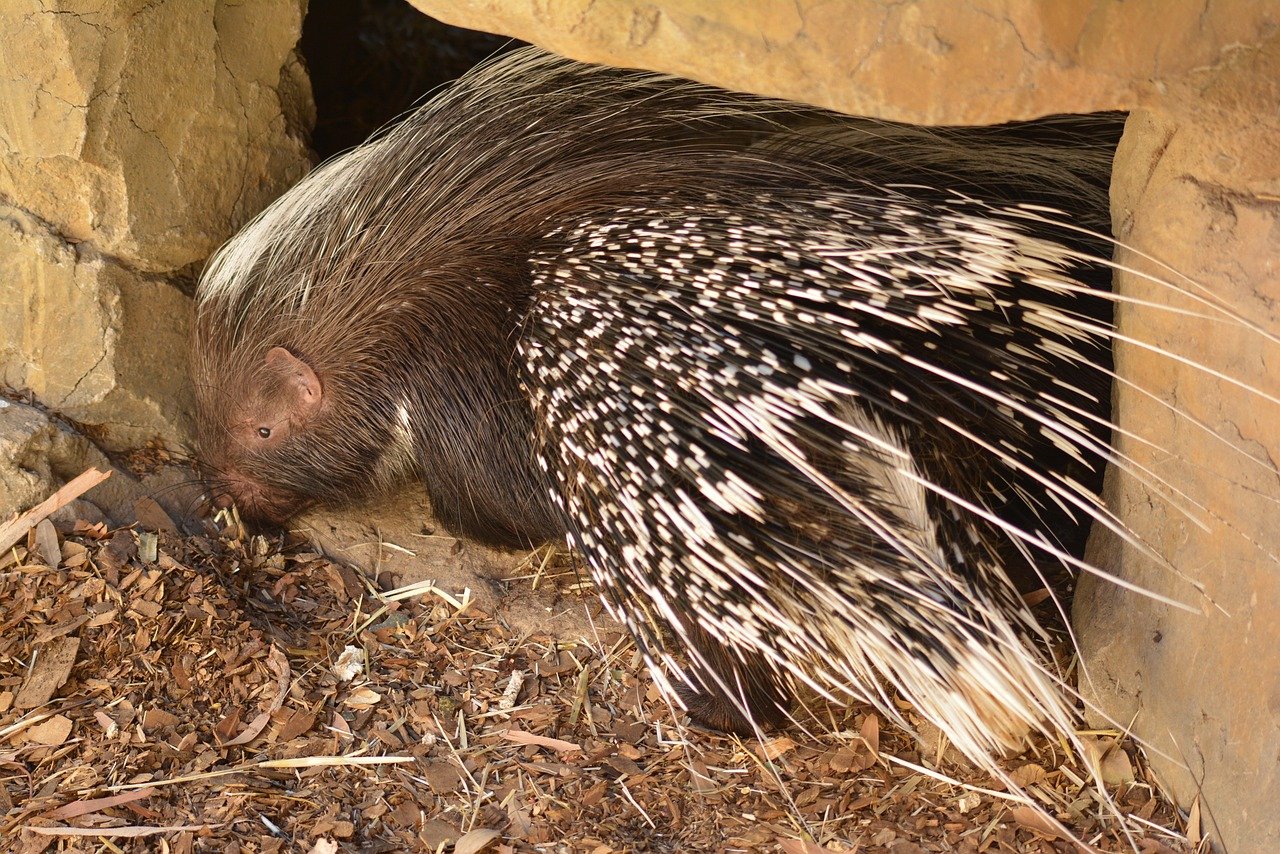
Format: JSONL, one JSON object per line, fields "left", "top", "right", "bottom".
{"left": 1075, "top": 38, "right": 1280, "bottom": 851}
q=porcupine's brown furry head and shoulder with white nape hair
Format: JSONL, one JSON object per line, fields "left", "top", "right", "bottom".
{"left": 192, "top": 152, "right": 556, "bottom": 547}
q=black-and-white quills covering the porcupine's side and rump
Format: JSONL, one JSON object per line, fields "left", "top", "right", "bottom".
{"left": 518, "top": 191, "right": 1116, "bottom": 758}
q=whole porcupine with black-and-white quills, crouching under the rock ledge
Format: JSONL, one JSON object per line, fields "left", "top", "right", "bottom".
{"left": 192, "top": 50, "right": 1119, "bottom": 788}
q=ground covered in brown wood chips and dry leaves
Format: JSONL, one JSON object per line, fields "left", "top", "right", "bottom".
{"left": 0, "top": 468, "right": 1198, "bottom": 854}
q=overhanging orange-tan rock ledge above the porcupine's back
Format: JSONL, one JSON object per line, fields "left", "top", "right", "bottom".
{"left": 410, "top": 0, "right": 1280, "bottom": 124}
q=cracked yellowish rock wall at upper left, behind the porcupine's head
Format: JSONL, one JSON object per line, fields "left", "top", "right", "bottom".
{"left": 0, "top": 0, "right": 311, "bottom": 448}
